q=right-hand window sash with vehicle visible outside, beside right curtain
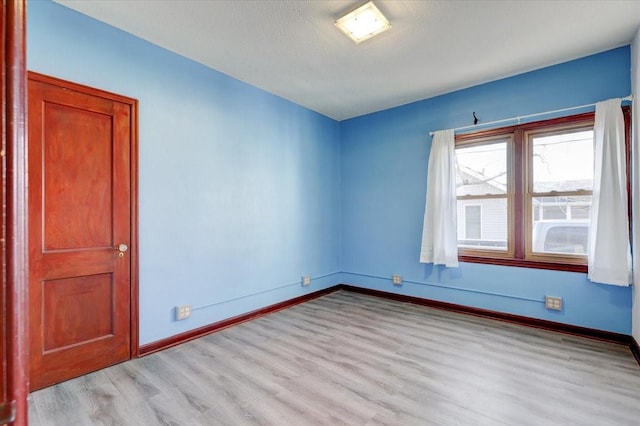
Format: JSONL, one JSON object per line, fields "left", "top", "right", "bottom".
{"left": 525, "top": 124, "right": 593, "bottom": 263}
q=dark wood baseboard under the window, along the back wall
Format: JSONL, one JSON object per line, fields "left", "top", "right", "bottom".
{"left": 339, "top": 284, "right": 633, "bottom": 346}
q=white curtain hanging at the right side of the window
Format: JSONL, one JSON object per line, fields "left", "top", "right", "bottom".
{"left": 588, "top": 99, "right": 631, "bottom": 286}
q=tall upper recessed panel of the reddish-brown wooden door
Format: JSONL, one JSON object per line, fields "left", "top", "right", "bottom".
{"left": 42, "top": 103, "right": 113, "bottom": 252}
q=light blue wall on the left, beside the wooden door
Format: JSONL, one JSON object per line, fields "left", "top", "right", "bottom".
{"left": 27, "top": 1, "right": 340, "bottom": 344}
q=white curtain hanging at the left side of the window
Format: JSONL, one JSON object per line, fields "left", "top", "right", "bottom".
{"left": 420, "top": 130, "right": 458, "bottom": 267}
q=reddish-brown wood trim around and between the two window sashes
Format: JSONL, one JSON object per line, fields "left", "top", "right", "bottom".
{"left": 455, "top": 106, "right": 632, "bottom": 273}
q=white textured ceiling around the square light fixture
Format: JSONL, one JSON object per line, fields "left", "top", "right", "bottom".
{"left": 56, "top": 0, "right": 640, "bottom": 120}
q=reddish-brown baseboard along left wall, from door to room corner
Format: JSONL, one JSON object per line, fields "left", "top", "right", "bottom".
{"left": 138, "top": 286, "right": 339, "bottom": 356}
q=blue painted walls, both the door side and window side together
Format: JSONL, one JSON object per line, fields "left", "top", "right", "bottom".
{"left": 27, "top": 1, "right": 631, "bottom": 344}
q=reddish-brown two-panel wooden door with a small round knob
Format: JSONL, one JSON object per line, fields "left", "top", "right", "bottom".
{"left": 28, "top": 73, "right": 135, "bottom": 390}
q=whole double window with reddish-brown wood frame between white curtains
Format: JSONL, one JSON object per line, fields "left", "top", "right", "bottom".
{"left": 456, "top": 108, "right": 630, "bottom": 271}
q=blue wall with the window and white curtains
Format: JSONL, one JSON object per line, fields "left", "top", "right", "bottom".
{"left": 340, "top": 46, "right": 632, "bottom": 334}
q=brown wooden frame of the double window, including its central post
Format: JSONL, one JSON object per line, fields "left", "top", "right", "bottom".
{"left": 455, "top": 106, "right": 632, "bottom": 273}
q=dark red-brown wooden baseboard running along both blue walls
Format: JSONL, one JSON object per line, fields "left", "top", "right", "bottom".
{"left": 138, "top": 284, "right": 640, "bottom": 365}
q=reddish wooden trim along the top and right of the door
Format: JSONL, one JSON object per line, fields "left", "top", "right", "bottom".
{"left": 27, "top": 71, "right": 140, "bottom": 358}
